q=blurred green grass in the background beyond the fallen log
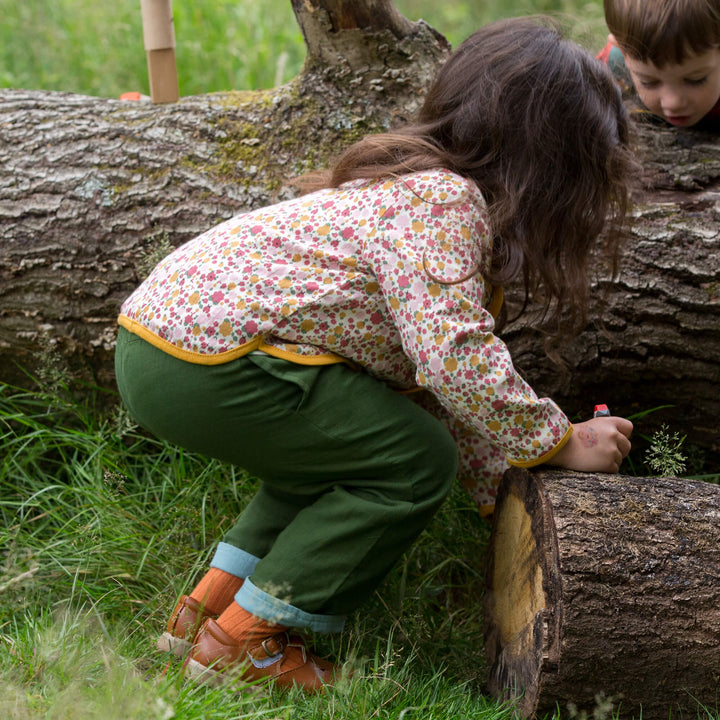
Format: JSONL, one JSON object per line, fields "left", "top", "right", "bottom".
{"left": 0, "top": 0, "right": 607, "bottom": 97}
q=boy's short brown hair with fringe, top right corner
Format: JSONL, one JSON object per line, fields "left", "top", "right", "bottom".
{"left": 603, "top": 0, "right": 720, "bottom": 68}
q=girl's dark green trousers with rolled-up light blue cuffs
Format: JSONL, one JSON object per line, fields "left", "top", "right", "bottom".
{"left": 115, "top": 328, "right": 457, "bottom": 631}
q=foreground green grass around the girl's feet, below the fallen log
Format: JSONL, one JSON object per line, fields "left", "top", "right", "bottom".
{"left": 0, "top": 386, "right": 498, "bottom": 720}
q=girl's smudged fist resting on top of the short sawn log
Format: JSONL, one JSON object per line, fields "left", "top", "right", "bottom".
{"left": 547, "top": 417, "right": 632, "bottom": 473}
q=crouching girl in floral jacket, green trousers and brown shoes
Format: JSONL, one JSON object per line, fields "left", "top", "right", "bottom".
{"left": 116, "top": 19, "right": 632, "bottom": 691}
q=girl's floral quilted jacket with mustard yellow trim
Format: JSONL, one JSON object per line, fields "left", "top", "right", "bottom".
{"left": 119, "top": 170, "right": 571, "bottom": 506}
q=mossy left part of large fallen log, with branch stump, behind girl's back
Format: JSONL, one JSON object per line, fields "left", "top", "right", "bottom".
{"left": 0, "top": 0, "right": 450, "bottom": 390}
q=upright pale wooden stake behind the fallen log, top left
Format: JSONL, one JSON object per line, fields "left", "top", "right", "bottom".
{"left": 140, "top": 0, "right": 180, "bottom": 103}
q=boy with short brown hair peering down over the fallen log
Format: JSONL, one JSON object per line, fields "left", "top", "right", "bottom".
{"left": 598, "top": 0, "right": 720, "bottom": 127}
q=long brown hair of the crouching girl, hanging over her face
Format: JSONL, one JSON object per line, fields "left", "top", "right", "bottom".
{"left": 298, "top": 17, "right": 634, "bottom": 359}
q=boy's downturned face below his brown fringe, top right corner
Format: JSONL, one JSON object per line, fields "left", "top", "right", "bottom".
{"left": 625, "top": 48, "right": 720, "bottom": 127}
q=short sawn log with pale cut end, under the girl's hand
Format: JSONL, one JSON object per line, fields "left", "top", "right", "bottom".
{"left": 485, "top": 468, "right": 720, "bottom": 720}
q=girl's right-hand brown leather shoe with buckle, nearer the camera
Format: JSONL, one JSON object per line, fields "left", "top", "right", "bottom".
{"left": 185, "top": 618, "right": 339, "bottom": 692}
